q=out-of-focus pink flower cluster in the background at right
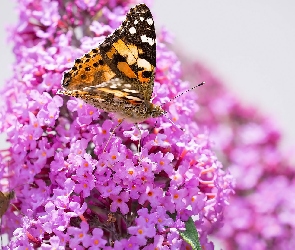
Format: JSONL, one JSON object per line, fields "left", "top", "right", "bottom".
{"left": 185, "top": 62, "right": 295, "bottom": 250}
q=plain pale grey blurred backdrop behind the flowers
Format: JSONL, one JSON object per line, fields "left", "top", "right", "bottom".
{"left": 0, "top": 0, "right": 295, "bottom": 148}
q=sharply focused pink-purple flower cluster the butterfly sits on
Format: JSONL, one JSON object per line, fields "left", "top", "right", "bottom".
{"left": 0, "top": 0, "right": 232, "bottom": 249}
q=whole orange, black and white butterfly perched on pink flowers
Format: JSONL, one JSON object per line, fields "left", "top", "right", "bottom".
{"left": 60, "top": 4, "right": 165, "bottom": 123}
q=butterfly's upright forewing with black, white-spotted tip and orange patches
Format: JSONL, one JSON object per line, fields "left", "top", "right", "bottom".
{"left": 100, "top": 4, "right": 156, "bottom": 101}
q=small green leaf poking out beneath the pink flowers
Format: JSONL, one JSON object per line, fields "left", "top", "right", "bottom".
{"left": 179, "top": 218, "right": 202, "bottom": 250}
